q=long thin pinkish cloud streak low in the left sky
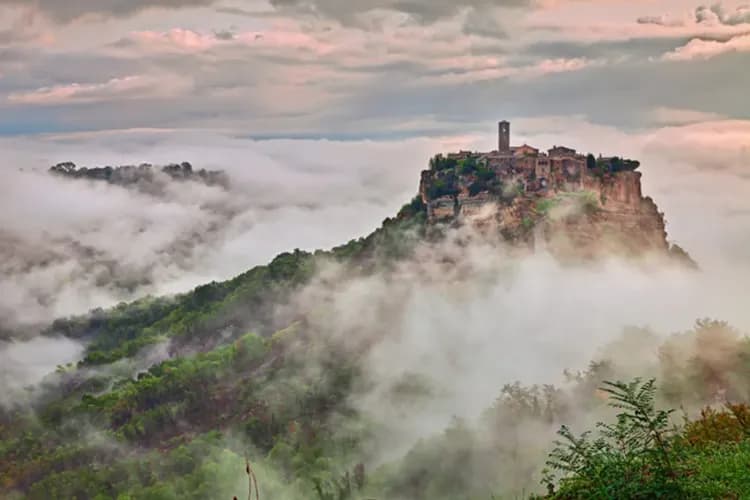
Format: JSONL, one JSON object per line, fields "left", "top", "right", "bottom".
{"left": 8, "top": 75, "right": 190, "bottom": 105}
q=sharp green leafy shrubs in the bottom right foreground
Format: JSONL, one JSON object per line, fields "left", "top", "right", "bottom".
{"left": 545, "top": 379, "right": 750, "bottom": 500}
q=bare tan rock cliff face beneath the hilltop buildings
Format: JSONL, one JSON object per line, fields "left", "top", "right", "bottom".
{"left": 419, "top": 170, "right": 669, "bottom": 258}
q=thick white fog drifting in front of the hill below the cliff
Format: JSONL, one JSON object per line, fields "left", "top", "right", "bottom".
{"left": 278, "top": 223, "right": 750, "bottom": 468}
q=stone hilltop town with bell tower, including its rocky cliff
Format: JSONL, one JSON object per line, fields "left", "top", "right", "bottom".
{"left": 417, "top": 121, "right": 684, "bottom": 257}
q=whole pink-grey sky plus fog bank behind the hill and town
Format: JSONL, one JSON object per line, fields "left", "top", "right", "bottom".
{"left": 0, "top": 0, "right": 750, "bottom": 333}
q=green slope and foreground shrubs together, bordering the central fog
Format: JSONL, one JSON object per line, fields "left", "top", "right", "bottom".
{"left": 0, "top": 200, "right": 750, "bottom": 500}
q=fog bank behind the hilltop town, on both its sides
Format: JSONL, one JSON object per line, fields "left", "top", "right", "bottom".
{"left": 0, "top": 116, "right": 750, "bottom": 336}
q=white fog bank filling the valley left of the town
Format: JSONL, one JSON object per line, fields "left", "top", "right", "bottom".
{"left": 0, "top": 132, "right": 478, "bottom": 330}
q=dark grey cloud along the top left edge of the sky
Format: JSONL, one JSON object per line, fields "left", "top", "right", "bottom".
{"left": 0, "top": 0, "right": 216, "bottom": 23}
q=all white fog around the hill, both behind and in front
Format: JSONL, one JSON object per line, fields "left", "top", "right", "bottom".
{"left": 0, "top": 119, "right": 750, "bottom": 500}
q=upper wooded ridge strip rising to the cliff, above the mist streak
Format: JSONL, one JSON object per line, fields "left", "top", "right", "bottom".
{"left": 46, "top": 201, "right": 425, "bottom": 366}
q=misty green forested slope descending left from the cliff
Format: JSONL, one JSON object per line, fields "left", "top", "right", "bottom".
{"left": 0, "top": 205, "right": 434, "bottom": 499}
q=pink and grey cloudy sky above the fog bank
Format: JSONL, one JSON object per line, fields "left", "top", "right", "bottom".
{"left": 0, "top": 0, "right": 750, "bottom": 139}
